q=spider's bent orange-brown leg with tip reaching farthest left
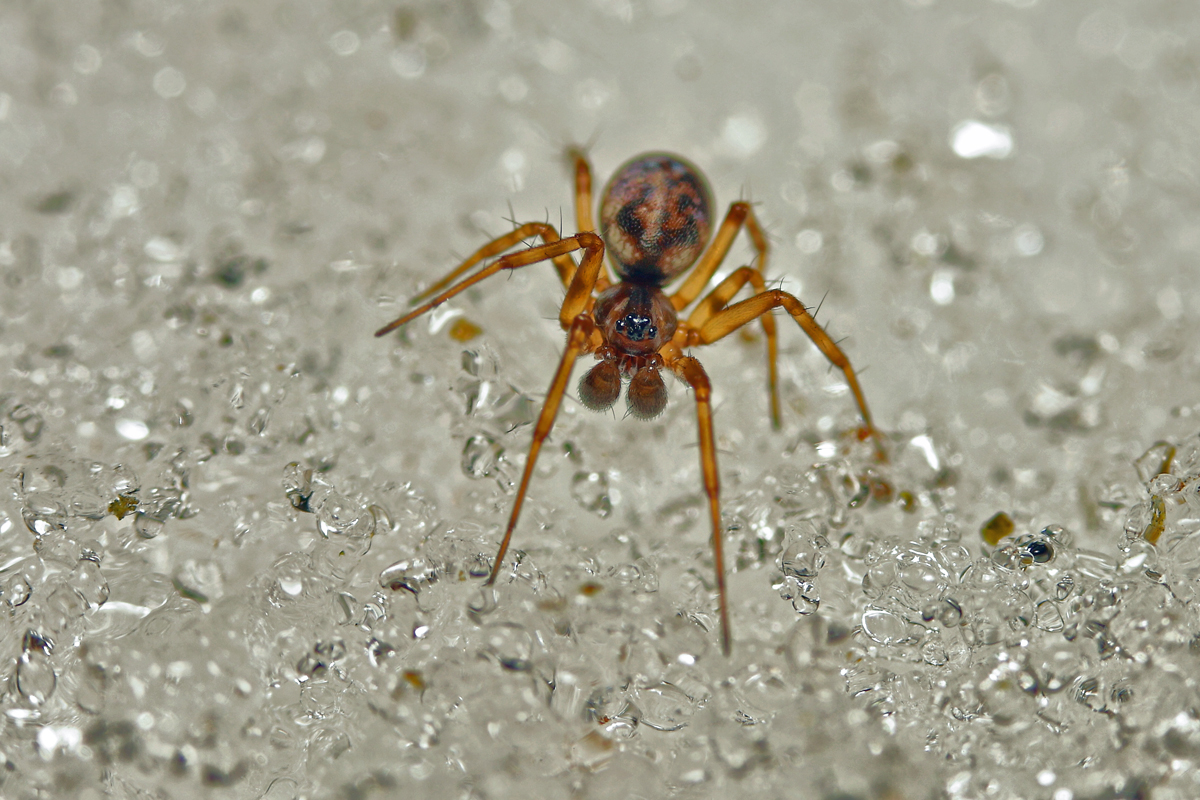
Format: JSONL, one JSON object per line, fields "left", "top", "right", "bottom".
{"left": 376, "top": 233, "right": 604, "bottom": 336}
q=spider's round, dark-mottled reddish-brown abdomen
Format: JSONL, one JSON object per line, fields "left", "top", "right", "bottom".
{"left": 600, "top": 152, "right": 713, "bottom": 285}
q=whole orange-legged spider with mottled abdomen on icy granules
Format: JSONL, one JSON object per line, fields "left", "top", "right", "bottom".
{"left": 376, "top": 152, "right": 884, "bottom": 655}
